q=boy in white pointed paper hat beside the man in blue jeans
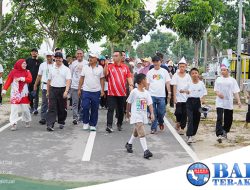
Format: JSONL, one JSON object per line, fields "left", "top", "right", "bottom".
{"left": 171, "top": 57, "right": 191, "bottom": 135}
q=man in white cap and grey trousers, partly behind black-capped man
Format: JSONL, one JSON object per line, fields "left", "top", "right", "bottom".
{"left": 34, "top": 51, "right": 54, "bottom": 125}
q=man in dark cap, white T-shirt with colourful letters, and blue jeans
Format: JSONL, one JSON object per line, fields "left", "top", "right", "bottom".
{"left": 147, "top": 56, "right": 171, "bottom": 134}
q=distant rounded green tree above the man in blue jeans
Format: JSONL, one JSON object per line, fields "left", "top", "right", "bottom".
{"left": 136, "top": 30, "right": 177, "bottom": 57}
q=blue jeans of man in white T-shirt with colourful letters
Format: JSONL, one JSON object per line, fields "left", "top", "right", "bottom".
{"left": 151, "top": 96, "right": 166, "bottom": 130}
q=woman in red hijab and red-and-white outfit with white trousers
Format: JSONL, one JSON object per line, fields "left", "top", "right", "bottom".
{"left": 2, "top": 59, "right": 32, "bottom": 131}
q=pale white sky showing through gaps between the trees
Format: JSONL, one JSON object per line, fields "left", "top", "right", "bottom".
{"left": 3, "top": 0, "right": 174, "bottom": 55}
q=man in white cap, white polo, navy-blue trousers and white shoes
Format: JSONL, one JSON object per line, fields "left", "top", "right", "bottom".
{"left": 78, "top": 54, "right": 104, "bottom": 131}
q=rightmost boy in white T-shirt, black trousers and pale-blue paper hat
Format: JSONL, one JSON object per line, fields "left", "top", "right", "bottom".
{"left": 214, "top": 65, "right": 241, "bottom": 143}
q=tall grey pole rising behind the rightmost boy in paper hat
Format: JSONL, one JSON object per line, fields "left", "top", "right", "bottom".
{"left": 236, "top": 0, "right": 242, "bottom": 86}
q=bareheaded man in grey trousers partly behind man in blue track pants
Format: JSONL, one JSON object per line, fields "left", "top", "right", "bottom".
{"left": 70, "top": 49, "right": 88, "bottom": 125}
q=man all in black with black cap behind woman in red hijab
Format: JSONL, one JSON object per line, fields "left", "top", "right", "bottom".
{"left": 26, "top": 48, "right": 41, "bottom": 115}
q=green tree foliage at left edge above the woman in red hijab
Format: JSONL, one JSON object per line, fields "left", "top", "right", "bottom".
{"left": 0, "top": 7, "right": 44, "bottom": 74}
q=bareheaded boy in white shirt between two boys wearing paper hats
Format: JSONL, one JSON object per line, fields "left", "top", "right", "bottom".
{"left": 186, "top": 68, "right": 207, "bottom": 144}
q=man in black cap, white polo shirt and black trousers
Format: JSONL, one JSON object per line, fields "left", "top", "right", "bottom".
{"left": 47, "top": 52, "right": 71, "bottom": 131}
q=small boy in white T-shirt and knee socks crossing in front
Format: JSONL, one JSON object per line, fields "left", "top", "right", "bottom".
{"left": 125, "top": 73, "right": 154, "bottom": 159}
